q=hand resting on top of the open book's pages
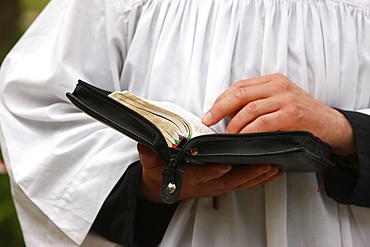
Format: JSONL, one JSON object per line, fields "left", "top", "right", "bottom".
{"left": 203, "top": 74, "right": 355, "bottom": 155}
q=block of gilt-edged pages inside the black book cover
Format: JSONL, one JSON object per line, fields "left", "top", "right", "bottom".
{"left": 108, "top": 91, "right": 216, "bottom": 147}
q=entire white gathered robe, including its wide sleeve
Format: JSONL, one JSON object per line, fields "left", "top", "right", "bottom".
{"left": 0, "top": 0, "right": 370, "bottom": 247}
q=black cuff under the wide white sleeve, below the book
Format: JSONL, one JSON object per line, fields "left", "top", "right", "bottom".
{"left": 91, "top": 162, "right": 178, "bottom": 247}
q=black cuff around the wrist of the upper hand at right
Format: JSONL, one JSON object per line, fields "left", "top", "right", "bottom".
{"left": 324, "top": 110, "right": 370, "bottom": 207}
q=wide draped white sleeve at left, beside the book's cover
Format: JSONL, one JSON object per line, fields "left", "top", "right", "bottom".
{"left": 0, "top": 0, "right": 137, "bottom": 246}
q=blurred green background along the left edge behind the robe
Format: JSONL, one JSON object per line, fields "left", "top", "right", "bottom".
{"left": 0, "top": 0, "right": 49, "bottom": 247}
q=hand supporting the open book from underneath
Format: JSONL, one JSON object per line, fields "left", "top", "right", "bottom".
{"left": 137, "top": 144, "right": 282, "bottom": 203}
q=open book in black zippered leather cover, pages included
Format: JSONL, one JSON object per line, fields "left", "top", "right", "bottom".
{"left": 66, "top": 80, "right": 335, "bottom": 203}
